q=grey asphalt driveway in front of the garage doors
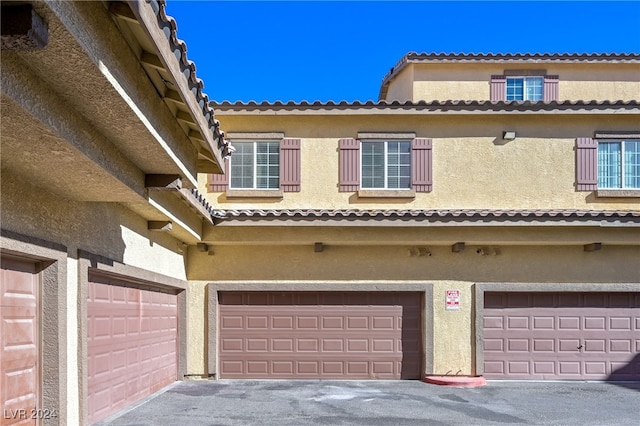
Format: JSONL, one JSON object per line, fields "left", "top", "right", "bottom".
{"left": 99, "top": 380, "right": 640, "bottom": 426}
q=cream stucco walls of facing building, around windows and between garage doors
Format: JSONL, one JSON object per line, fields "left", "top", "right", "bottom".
{"left": 196, "top": 100, "right": 640, "bottom": 380}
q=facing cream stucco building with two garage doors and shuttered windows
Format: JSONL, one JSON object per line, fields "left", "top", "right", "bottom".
{"left": 201, "top": 53, "right": 640, "bottom": 380}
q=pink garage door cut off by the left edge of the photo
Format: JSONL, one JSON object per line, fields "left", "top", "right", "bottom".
{"left": 0, "top": 256, "right": 40, "bottom": 425}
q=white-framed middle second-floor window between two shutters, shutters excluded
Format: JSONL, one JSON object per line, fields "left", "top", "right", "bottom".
{"left": 361, "top": 141, "right": 411, "bottom": 189}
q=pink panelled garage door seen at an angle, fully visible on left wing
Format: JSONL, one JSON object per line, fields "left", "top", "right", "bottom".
{"left": 87, "top": 282, "right": 178, "bottom": 423}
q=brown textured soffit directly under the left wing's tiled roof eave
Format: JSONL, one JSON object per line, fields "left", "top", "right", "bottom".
{"left": 3, "top": 3, "right": 196, "bottom": 180}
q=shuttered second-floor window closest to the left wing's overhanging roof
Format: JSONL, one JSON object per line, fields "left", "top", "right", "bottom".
{"left": 208, "top": 133, "right": 301, "bottom": 198}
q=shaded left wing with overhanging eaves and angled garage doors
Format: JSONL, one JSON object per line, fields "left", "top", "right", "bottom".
{"left": 0, "top": 1, "right": 229, "bottom": 425}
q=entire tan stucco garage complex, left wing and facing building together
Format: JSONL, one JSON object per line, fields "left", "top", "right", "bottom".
{"left": 0, "top": 1, "right": 640, "bottom": 424}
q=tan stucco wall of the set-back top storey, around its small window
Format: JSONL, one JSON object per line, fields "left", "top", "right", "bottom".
{"left": 387, "top": 63, "right": 640, "bottom": 101}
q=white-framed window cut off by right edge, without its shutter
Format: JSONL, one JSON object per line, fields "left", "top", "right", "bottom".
{"left": 598, "top": 140, "right": 640, "bottom": 189}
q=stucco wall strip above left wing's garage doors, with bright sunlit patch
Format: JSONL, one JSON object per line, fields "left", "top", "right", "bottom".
{"left": 1, "top": 171, "right": 186, "bottom": 279}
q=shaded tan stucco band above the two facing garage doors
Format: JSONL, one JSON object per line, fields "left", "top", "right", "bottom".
{"left": 188, "top": 243, "right": 640, "bottom": 283}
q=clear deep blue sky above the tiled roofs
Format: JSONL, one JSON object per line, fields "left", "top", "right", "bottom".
{"left": 167, "top": 0, "right": 640, "bottom": 102}
